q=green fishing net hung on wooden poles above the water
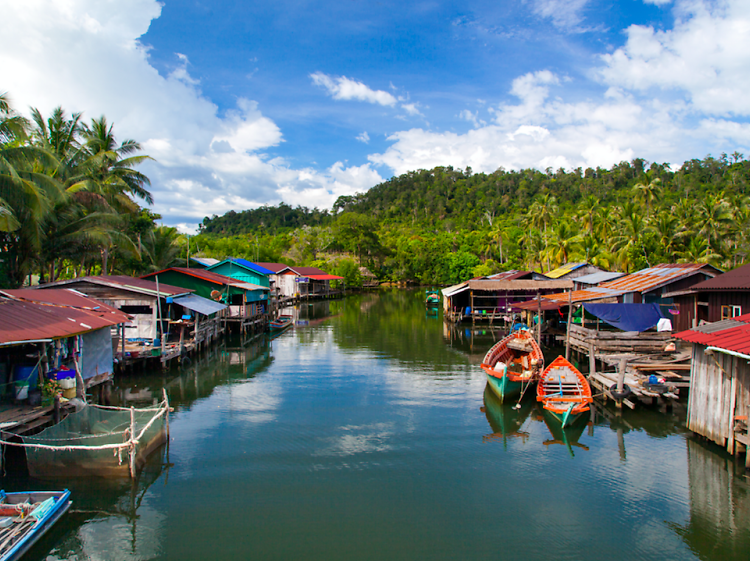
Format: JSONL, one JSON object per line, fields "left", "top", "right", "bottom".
{"left": 23, "top": 406, "right": 165, "bottom": 477}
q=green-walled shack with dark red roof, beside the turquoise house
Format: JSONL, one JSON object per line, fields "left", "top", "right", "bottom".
{"left": 141, "top": 267, "right": 270, "bottom": 333}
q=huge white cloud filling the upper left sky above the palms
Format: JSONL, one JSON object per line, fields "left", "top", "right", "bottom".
{"left": 0, "top": 0, "right": 384, "bottom": 229}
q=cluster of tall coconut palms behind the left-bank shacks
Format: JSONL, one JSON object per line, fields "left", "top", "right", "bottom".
{"left": 0, "top": 94, "right": 180, "bottom": 287}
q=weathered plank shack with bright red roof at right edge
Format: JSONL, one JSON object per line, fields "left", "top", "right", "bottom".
{"left": 675, "top": 314, "right": 750, "bottom": 469}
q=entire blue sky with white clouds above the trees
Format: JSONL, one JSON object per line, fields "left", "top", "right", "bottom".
{"left": 0, "top": 0, "right": 750, "bottom": 232}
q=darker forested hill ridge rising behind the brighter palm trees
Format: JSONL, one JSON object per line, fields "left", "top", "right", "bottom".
{"left": 201, "top": 153, "right": 750, "bottom": 235}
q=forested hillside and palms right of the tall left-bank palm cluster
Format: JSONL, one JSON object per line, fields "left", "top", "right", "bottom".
{"left": 198, "top": 152, "right": 750, "bottom": 284}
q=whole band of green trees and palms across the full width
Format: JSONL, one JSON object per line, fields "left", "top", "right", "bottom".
{"left": 0, "top": 90, "right": 750, "bottom": 286}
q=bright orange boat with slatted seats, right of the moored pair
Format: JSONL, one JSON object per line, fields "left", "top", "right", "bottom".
{"left": 536, "top": 356, "right": 594, "bottom": 428}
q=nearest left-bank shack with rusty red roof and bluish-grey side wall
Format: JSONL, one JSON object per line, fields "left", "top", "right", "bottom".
{"left": 0, "top": 289, "right": 130, "bottom": 397}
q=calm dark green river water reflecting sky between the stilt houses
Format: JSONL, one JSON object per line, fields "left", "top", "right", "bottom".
{"left": 3, "top": 291, "right": 750, "bottom": 561}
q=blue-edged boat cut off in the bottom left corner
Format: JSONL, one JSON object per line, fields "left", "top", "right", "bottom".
{"left": 0, "top": 489, "right": 70, "bottom": 561}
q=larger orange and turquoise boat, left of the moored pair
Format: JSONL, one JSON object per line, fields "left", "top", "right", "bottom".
{"left": 481, "top": 329, "right": 544, "bottom": 403}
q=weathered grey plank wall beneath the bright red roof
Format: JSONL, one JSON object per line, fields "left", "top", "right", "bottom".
{"left": 687, "top": 344, "right": 750, "bottom": 453}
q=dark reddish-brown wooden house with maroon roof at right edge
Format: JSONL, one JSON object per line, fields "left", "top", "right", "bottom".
{"left": 665, "top": 264, "right": 750, "bottom": 331}
